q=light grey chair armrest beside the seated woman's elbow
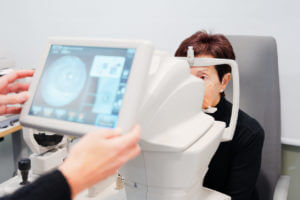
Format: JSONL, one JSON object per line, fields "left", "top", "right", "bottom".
{"left": 273, "top": 176, "right": 291, "bottom": 200}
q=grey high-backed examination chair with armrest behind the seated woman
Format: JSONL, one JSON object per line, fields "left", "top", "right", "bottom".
{"left": 226, "top": 36, "right": 290, "bottom": 200}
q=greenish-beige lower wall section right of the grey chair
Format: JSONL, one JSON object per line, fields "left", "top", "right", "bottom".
{"left": 282, "top": 145, "right": 300, "bottom": 200}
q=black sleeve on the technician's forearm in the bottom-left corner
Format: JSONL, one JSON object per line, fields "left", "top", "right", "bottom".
{"left": 0, "top": 170, "right": 71, "bottom": 200}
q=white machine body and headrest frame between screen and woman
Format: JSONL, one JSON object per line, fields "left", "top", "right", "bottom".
{"left": 120, "top": 52, "right": 239, "bottom": 200}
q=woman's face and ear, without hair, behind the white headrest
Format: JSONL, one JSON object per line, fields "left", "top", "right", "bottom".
{"left": 190, "top": 55, "right": 231, "bottom": 109}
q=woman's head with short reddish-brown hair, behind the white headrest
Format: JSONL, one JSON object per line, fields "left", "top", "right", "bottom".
{"left": 175, "top": 31, "right": 235, "bottom": 108}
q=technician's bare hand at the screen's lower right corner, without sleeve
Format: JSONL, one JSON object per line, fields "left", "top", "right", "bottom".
{"left": 59, "top": 126, "right": 141, "bottom": 198}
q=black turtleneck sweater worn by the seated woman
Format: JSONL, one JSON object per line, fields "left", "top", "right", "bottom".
{"left": 204, "top": 97, "right": 264, "bottom": 200}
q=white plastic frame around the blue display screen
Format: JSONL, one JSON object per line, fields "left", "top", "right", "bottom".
{"left": 20, "top": 38, "right": 154, "bottom": 136}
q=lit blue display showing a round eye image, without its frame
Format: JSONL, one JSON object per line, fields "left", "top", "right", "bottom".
{"left": 29, "top": 45, "right": 136, "bottom": 128}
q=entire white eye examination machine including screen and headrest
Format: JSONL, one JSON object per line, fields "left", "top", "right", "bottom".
{"left": 0, "top": 38, "right": 239, "bottom": 200}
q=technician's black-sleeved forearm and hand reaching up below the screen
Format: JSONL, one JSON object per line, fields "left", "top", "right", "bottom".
{"left": 0, "top": 126, "right": 141, "bottom": 200}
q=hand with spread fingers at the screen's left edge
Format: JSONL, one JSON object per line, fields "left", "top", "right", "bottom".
{"left": 0, "top": 70, "right": 34, "bottom": 115}
